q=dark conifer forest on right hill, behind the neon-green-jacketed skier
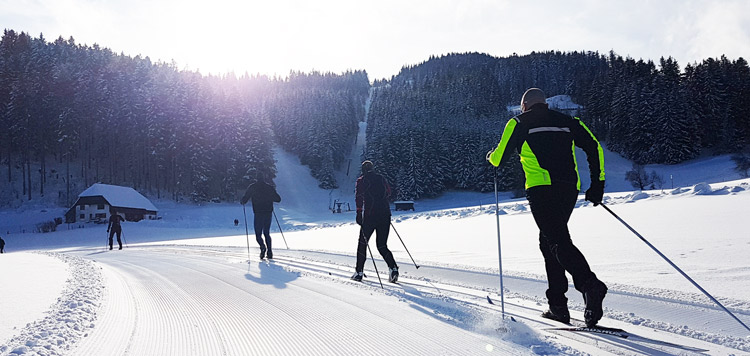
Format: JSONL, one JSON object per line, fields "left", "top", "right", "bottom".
{"left": 366, "top": 51, "right": 750, "bottom": 199}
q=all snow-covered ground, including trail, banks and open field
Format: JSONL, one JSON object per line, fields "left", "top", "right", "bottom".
{"left": 0, "top": 143, "right": 750, "bottom": 355}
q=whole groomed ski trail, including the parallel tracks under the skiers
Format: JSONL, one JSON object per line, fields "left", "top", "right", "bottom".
{"left": 72, "top": 245, "right": 742, "bottom": 355}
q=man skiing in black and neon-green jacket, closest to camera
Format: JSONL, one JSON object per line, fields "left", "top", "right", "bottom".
{"left": 487, "top": 88, "right": 607, "bottom": 327}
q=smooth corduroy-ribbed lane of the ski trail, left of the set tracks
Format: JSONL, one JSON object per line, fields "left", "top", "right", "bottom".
{"left": 74, "top": 248, "right": 528, "bottom": 355}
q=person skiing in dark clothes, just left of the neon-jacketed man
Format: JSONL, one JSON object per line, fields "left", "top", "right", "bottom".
{"left": 352, "top": 161, "right": 398, "bottom": 283}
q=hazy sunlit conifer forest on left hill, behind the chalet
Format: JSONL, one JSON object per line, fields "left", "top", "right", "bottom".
{"left": 0, "top": 30, "right": 369, "bottom": 209}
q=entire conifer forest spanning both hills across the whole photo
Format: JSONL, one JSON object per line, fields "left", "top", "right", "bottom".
{"left": 0, "top": 30, "right": 750, "bottom": 205}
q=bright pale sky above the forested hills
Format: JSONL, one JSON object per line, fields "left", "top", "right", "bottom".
{"left": 0, "top": 0, "right": 750, "bottom": 80}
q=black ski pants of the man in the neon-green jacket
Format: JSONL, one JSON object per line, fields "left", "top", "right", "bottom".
{"left": 526, "top": 185, "right": 597, "bottom": 306}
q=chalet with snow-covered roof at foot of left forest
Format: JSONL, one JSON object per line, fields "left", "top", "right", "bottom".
{"left": 65, "top": 183, "right": 159, "bottom": 223}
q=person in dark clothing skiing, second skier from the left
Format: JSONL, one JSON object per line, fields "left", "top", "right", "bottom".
{"left": 240, "top": 173, "right": 281, "bottom": 259}
